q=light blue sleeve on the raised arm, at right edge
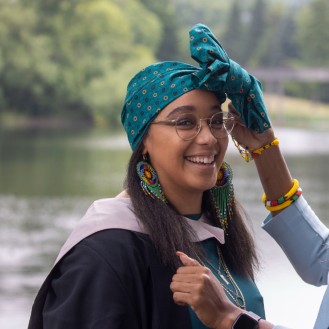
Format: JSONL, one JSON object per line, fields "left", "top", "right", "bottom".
{"left": 262, "top": 196, "right": 329, "bottom": 286}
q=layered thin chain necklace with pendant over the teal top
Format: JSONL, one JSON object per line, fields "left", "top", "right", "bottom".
{"left": 199, "top": 246, "right": 246, "bottom": 310}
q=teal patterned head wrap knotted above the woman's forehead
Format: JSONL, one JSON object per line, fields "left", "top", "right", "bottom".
{"left": 121, "top": 24, "right": 271, "bottom": 150}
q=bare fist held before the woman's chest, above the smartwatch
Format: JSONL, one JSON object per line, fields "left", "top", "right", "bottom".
{"left": 170, "top": 252, "right": 242, "bottom": 329}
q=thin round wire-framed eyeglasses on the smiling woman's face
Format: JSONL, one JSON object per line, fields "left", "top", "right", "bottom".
{"left": 152, "top": 112, "right": 235, "bottom": 141}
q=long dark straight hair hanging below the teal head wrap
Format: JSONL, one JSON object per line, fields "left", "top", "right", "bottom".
{"left": 125, "top": 142, "right": 258, "bottom": 278}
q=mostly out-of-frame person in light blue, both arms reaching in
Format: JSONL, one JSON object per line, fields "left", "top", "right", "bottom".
{"left": 171, "top": 66, "right": 329, "bottom": 329}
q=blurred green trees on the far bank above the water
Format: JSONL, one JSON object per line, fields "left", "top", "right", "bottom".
{"left": 0, "top": 0, "right": 329, "bottom": 127}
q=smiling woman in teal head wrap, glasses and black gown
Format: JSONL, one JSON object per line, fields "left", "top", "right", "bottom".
{"left": 29, "top": 24, "right": 273, "bottom": 329}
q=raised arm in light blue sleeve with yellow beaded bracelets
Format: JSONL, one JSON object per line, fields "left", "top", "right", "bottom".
{"left": 230, "top": 102, "right": 329, "bottom": 285}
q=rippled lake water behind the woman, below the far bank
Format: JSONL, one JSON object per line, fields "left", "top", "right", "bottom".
{"left": 0, "top": 129, "right": 329, "bottom": 329}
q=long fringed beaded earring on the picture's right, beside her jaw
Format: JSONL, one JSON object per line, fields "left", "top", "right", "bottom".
{"left": 210, "top": 162, "right": 234, "bottom": 234}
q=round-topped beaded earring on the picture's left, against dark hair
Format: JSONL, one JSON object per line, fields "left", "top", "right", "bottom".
{"left": 136, "top": 155, "right": 167, "bottom": 203}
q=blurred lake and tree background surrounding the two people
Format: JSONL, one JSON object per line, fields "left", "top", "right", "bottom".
{"left": 0, "top": 0, "right": 329, "bottom": 329}
